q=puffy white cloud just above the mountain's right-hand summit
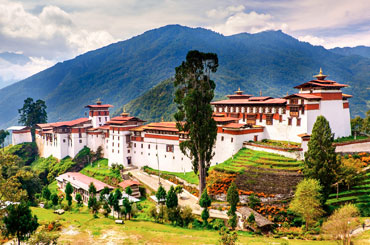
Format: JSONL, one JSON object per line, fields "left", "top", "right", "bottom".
{"left": 211, "top": 11, "right": 287, "bottom": 35}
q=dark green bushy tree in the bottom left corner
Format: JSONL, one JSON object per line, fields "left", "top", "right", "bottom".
{"left": 3, "top": 202, "right": 39, "bottom": 244}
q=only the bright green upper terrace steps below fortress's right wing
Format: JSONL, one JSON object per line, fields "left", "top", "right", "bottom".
{"left": 211, "top": 148, "right": 303, "bottom": 173}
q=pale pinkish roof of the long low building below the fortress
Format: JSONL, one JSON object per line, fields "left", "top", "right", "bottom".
{"left": 56, "top": 172, "right": 114, "bottom": 192}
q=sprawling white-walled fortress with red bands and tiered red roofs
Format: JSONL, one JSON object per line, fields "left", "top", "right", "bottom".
{"left": 7, "top": 69, "right": 351, "bottom": 172}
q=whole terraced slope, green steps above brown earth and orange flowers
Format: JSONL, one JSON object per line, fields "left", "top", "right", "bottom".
{"left": 208, "top": 149, "right": 303, "bottom": 200}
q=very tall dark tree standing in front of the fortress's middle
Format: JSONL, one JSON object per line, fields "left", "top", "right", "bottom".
{"left": 174, "top": 50, "right": 218, "bottom": 196}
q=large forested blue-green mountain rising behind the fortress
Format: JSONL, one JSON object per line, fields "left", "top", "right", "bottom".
{"left": 0, "top": 25, "right": 370, "bottom": 128}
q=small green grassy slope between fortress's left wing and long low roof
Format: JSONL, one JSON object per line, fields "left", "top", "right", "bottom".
{"left": 80, "top": 158, "right": 122, "bottom": 185}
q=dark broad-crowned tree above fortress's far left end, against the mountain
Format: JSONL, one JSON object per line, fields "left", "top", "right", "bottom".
{"left": 18, "top": 97, "right": 48, "bottom": 142}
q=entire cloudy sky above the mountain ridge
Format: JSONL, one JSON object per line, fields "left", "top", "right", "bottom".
{"left": 0, "top": 0, "right": 370, "bottom": 86}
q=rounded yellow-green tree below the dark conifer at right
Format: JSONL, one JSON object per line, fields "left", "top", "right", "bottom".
{"left": 289, "top": 179, "right": 324, "bottom": 230}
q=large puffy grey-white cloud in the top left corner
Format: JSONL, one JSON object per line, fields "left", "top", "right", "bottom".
{"left": 0, "top": 1, "right": 117, "bottom": 60}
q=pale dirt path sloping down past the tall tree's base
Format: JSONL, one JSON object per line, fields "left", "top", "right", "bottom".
{"left": 130, "top": 169, "right": 228, "bottom": 219}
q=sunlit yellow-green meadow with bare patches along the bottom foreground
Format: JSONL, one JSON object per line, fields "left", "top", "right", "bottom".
{"left": 32, "top": 207, "right": 335, "bottom": 245}
